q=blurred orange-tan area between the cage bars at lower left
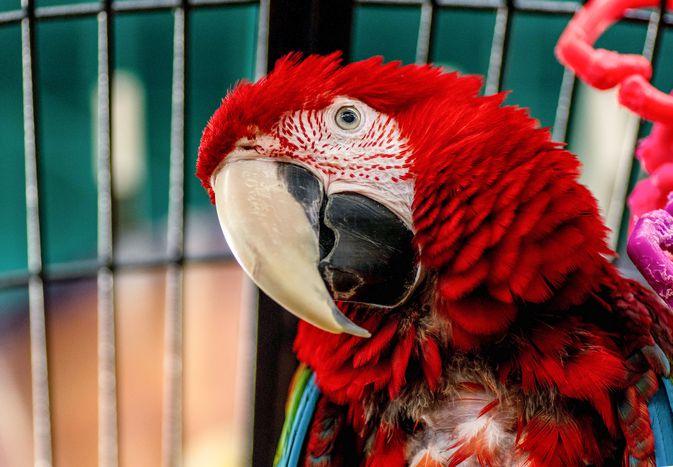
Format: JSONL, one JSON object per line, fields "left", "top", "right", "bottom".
{"left": 0, "top": 263, "right": 250, "bottom": 467}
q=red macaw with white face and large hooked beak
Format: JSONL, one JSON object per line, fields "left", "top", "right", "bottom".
{"left": 196, "top": 53, "right": 673, "bottom": 467}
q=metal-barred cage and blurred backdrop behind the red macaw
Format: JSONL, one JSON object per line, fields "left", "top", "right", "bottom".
{"left": 0, "top": 0, "right": 673, "bottom": 467}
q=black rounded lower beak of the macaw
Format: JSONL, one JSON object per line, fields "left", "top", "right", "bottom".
{"left": 319, "top": 193, "right": 418, "bottom": 307}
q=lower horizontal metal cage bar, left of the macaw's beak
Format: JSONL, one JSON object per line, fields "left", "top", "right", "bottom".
{"left": 0, "top": 252, "right": 234, "bottom": 290}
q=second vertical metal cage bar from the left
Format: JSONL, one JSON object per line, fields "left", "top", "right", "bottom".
{"left": 96, "top": 0, "right": 119, "bottom": 467}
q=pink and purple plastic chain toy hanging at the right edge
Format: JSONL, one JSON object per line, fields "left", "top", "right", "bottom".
{"left": 556, "top": 0, "right": 673, "bottom": 294}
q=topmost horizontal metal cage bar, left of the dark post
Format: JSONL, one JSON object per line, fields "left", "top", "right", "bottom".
{"left": 0, "top": 0, "right": 258, "bottom": 25}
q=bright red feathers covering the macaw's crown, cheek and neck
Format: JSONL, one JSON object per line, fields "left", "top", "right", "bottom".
{"left": 197, "top": 54, "right": 610, "bottom": 347}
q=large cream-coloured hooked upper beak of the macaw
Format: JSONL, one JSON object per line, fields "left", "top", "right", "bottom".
{"left": 212, "top": 160, "right": 370, "bottom": 337}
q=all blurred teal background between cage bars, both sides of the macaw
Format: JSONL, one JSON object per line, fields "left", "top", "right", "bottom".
{"left": 0, "top": 0, "right": 673, "bottom": 274}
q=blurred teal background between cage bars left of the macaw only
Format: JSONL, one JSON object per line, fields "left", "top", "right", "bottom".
{"left": 0, "top": 0, "right": 257, "bottom": 272}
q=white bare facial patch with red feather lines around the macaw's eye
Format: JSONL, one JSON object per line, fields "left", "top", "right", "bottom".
{"left": 256, "top": 97, "right": 414, "bottom": 228}
